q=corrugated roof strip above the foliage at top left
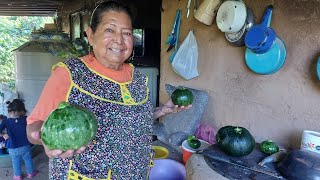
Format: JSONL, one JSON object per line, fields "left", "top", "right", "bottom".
{"left": 0, "top": 0, "right": 70, "bottom": 16}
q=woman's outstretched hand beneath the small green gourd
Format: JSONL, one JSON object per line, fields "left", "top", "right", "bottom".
{"left": 154, "top": 99, "right": 192, "bottom": 119}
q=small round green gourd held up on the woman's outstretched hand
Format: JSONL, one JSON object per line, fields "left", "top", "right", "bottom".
{"left": 171, "top": 87, "right": 193, "bottom": 106}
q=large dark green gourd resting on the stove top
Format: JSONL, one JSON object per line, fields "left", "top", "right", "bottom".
{"left": 216, "top": 126, "right": 256, "bottom": 157}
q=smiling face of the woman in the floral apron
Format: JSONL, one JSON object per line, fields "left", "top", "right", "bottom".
{"left": 87, "top": 11, "right": 133, "bottom": 69}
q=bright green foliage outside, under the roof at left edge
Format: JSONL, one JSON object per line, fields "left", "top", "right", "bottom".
{"left": 0, "top": 16, "right": 53, "bottom": 88}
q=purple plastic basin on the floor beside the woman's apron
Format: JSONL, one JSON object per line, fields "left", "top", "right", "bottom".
{"left": 149, "top": 159, "right": 186, "bottom": 180}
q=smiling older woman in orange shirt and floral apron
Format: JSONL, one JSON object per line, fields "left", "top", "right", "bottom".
{"left": 27, "top": 1, "right": 191, "bottom": 180}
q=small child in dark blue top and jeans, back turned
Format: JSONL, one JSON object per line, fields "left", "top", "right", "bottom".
{"left": 0, "top": 99, "right": 38, "bottom": 180}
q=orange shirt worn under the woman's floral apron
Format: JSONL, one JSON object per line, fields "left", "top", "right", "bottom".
{"left": 27, "top": 55, "right": 132, "bottom": 124}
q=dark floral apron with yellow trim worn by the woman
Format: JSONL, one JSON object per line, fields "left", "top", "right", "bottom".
{"left": 49, "top": 58, "right": 153, "bottom": 180}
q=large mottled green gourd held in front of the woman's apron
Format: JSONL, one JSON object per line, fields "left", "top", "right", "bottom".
{"left": 41, "top": 102, "right": 98, "bottom": 151}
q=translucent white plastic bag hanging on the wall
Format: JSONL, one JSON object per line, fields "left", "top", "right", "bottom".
{"left": 171, "top": 31, "right": 199, "bottom": 80}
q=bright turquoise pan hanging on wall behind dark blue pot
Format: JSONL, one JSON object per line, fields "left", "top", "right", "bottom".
{"left": 245, "top": 37, "right": 287, "bottom": 75}
